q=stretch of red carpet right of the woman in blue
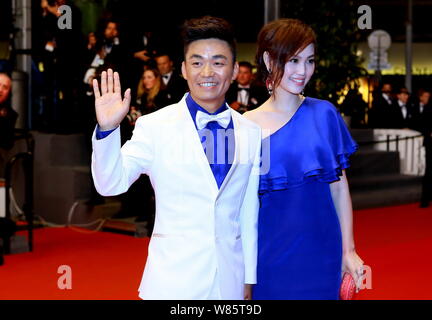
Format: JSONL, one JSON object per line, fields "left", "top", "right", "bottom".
{"left": 355, "top": 203, "right": 432, "bottom": 300}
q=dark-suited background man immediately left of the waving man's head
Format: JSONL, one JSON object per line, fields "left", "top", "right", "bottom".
{"left": 155, "top": 53, "right": 188, "bottom": 105}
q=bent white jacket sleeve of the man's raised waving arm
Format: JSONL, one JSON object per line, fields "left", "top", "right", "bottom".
{"left": 91, "top": 117, "right": 154, "bottom": 196}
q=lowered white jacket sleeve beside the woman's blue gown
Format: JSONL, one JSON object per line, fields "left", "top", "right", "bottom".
{"left": 240, "top": 130, "right": 261, "bottom": 284}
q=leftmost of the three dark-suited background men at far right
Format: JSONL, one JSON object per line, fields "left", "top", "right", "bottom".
{"left": 368, "top": 83, "right": 393, "bottom": 128}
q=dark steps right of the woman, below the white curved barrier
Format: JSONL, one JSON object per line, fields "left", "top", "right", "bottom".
{"left": 347, "top": 129, "right": 422, "bottom": 209}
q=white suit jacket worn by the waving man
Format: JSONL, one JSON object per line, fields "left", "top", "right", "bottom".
{"left": 92, "top": 96, "right": 261, "bottom": 300}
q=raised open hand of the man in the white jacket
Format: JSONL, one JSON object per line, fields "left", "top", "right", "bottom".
{"left": 93, "top": 69, "right": 131, "bottom": 131}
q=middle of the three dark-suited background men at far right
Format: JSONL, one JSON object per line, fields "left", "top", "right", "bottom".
{"left": 390, "top": 87, "right": 415, "bottom": 129}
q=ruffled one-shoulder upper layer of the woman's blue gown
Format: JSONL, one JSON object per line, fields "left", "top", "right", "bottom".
{"left": 259, "top": 98, "right": 358, "bottom": 194}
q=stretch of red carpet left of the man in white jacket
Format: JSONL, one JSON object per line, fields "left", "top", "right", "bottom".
{"left": 0, "top": 228, "right": 148, "bottom": 300}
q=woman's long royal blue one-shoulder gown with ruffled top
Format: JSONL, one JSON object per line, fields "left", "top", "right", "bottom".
{"left": 253, "top": 97, "right": 358, "bottom": 300}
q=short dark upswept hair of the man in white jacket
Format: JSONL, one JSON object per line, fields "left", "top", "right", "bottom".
{"left": 182, "top": 16, "right": 237, "bottom": 62}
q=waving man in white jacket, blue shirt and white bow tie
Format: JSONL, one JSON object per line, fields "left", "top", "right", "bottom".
{"left": 92, "top": 16, "right": 261, "bottom": 300}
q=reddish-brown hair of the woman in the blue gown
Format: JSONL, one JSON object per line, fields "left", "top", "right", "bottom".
{"left": 256, "top": 19, "right": 316, "bottom": 92}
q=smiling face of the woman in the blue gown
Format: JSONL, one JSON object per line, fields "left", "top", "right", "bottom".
{"left": 276, "top": 43, "right": 315, "bottom": 94}
